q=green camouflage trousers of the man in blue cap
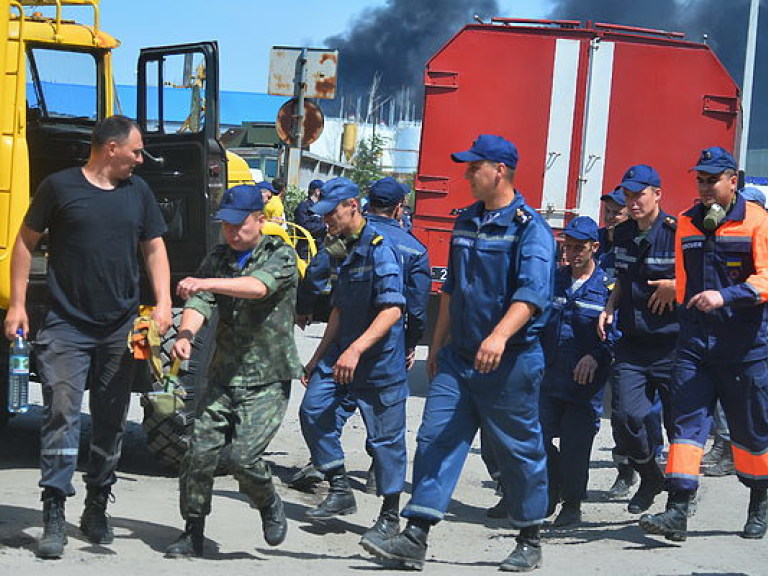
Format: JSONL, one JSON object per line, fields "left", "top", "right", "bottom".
{"left": 179, "top": 381, "right": 291, "bottom": 519}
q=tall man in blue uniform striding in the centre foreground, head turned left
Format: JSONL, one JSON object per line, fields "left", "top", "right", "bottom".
{"left": 361, "top": 135, "right": 555, "bottom": 571}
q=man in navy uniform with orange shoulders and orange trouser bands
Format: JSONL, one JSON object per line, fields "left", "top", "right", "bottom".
{"left": 640, "top": 146, "right": 768, "bottom": 541}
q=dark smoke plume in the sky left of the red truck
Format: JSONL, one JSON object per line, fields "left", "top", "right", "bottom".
{"left": 325, "top": 0, "right": 499, "bottom": 120}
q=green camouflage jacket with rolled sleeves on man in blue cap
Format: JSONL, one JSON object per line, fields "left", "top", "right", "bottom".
{"left": 185, "top": 235, "right": 302, "bottom": 386}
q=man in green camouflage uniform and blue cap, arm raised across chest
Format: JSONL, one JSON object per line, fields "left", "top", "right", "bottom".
{"left": 166, "top": 186, "right": 302, "bottom": 558}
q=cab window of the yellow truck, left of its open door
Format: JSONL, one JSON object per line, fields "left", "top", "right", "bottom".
{"left": 27, "top": 47, "right": 98, "bottom": 121}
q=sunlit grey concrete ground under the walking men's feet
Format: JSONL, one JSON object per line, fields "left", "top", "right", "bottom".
{"left": 0, "top": 325, "right": 768, "bottom": 576}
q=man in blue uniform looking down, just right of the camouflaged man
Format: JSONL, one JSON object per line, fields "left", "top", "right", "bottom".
{"left": 299, "top": 178, "right": 408, "bottom": 544}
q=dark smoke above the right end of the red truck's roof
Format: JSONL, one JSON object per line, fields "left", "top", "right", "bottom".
{"left": 549, "top": 0, "right": 768, "bottom": 148}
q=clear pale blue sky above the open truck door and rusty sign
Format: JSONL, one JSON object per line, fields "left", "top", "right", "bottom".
{"left": 101, "top": 0, "right": 549, "bottom": 92}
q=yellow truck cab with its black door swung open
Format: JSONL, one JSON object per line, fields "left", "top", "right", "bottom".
{"left": 0, "top": 0, "right": 312, "bottom": 464}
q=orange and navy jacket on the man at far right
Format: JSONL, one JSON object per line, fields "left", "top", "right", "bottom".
{"left": 675, "top": 195, "right": 768, "bottom": 362}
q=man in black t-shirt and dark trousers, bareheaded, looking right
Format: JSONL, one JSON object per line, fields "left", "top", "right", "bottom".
{"left": 5, "top": 116, "right": 171, "bottom": 558}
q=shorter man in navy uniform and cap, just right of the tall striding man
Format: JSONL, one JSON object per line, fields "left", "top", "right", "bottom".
{"left": 539, "top": 216, "right": 611, "bottom": 528}
